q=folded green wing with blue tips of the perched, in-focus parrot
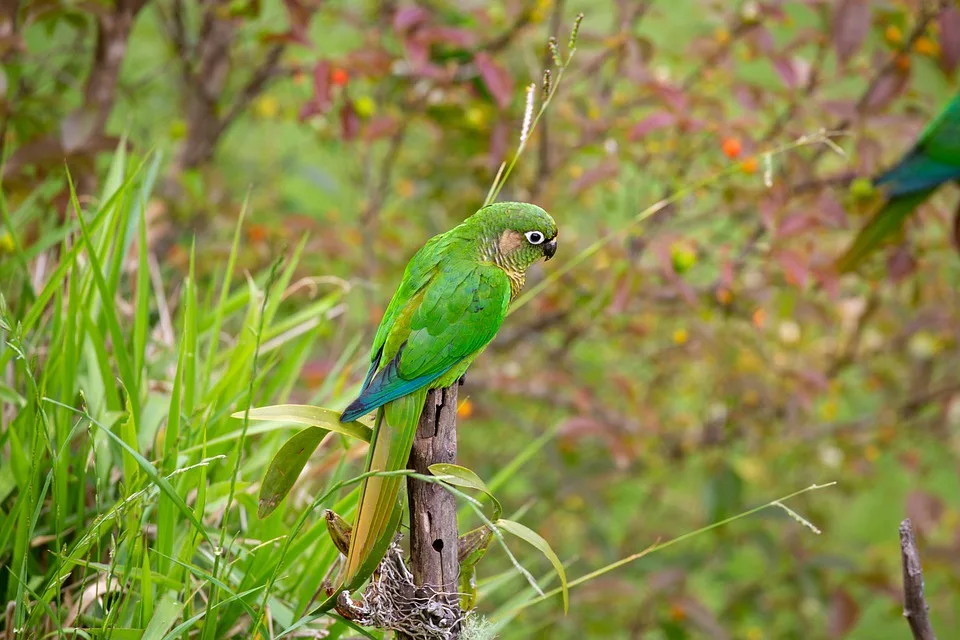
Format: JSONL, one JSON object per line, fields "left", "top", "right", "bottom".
{"left": 341, "top": 261, "right": 510, "bottom": 421}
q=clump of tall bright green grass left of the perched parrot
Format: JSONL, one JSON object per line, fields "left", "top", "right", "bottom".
{"left": 0, "top": 147, "right": 357, "bottom": 638}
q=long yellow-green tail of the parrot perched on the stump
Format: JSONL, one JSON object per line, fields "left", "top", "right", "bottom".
{"left": 344, "top": 389, "right": 427, "bottom": 587}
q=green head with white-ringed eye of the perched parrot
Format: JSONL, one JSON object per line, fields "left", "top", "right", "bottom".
{"left": 471, "top": 202, "right": 557, "bottom": 271}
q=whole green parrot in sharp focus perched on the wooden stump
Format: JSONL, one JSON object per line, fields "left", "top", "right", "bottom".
{"left": 340, "top": 202, "right": 557, "bottom": 585}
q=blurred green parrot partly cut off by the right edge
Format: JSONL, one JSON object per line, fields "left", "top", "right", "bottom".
{"left": 837, "top": 93, "right": 960, "bottom": 273}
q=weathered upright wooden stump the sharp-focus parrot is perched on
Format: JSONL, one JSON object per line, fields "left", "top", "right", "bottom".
{"left": 407, "top": 384, "right": 460, "bottom": 635}
